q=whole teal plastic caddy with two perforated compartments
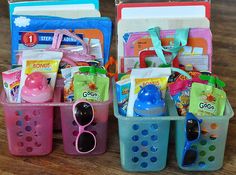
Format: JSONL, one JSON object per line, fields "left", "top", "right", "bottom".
{"left": 113, "top": 79, "right": 234, "bottom": 172}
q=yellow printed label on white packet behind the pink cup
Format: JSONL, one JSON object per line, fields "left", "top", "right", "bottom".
{"left": 25, "top": 60, "right": 58, "bottom": 74}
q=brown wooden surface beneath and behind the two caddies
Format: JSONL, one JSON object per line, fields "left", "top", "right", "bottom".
{"left": 0, "top": 0, "right": 236, "bottom": 175}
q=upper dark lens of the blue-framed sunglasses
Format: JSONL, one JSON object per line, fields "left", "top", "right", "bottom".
{"left": 186, "top": 119, "right": 199, "bottom": 141}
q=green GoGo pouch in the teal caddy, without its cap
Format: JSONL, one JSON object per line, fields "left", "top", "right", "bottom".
{"left": 189, "top": 83, "right": 226, "bottom": 116}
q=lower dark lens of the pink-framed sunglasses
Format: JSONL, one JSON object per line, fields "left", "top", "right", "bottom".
{"left": 77, "top": 132, "right": 95, "bottom": 153}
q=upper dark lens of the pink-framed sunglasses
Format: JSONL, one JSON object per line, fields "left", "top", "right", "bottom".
{"left": 75, "top": 102, "right": 93, "bottom": 126}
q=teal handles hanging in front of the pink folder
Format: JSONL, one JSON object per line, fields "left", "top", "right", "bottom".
{"left": 148, "top": 27, "right": 189, "bottom": 65}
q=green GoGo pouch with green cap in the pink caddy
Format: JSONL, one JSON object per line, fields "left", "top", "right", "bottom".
{"left": 74, "top": 66, "right": 110, "bottom": 102}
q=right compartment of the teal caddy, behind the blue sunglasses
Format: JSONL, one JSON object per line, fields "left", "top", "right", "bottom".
{"left": 175, "top": 101, "right": 234, "bottom": 171}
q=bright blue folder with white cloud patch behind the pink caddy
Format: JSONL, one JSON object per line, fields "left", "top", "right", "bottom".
{"left": 11, "top": 16, "right": 112, "bottom": 65}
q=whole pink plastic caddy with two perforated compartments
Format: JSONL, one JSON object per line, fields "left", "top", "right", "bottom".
{"left": 0, "top": 88, "right": 112, "bottom": 156}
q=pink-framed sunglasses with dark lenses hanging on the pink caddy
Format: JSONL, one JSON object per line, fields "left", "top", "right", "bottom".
{"left": 73, "top": 100, "right": 96, "bottom": 154}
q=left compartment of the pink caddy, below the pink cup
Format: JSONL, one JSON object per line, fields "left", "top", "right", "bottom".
{"left": 0, "top": 89, "right": 60, "bottom": 156}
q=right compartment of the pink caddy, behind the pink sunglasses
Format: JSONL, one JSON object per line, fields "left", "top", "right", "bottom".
{"left": 60, "top": 89, "right": 112, "bottom": 155}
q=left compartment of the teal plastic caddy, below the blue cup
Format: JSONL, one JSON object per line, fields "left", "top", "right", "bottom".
{"left": 113, "top": 83, "right": 179, "bottom": 172}
